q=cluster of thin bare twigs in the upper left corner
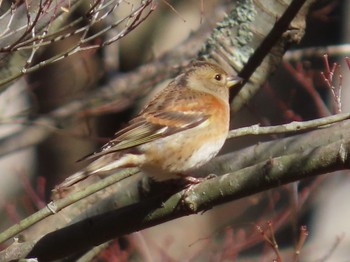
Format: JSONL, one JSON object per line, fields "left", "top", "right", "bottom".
{"left": 0, "top": 0, "right": 156, "bottom": 90}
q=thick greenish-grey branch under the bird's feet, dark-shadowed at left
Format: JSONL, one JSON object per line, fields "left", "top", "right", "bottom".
{"left": 23, "top": 123, "right": 350, "bottom": 261}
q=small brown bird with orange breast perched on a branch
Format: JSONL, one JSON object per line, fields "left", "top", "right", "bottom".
{"left": 57, "top": 61, "right": 241, "bottom": 189}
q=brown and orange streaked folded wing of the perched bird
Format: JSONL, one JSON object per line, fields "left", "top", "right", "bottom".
{"left": 81, "top": 87, "right": 209, "bottom": 160}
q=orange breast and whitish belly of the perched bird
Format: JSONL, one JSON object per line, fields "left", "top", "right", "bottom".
{"left": 138, "top": 92, "right": 229, "bottom": 180}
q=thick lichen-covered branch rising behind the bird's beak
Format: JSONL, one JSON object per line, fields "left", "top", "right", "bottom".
{"left": 202, "top": 0, "right": 314, "bottom": 112}
